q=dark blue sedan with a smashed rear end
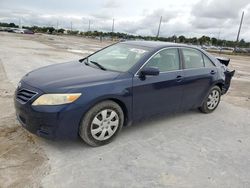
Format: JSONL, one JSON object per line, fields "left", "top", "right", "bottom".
{"left": 15, "top": 41, "right": 234, "bottom": 146}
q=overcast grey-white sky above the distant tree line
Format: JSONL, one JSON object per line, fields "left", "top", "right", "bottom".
{"left": 0, "top": 0, "right": 250, "bottom": 41}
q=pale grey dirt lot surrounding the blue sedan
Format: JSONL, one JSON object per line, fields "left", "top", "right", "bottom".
{"left": 0, "top": 33, "right": 250, "bottom": 187}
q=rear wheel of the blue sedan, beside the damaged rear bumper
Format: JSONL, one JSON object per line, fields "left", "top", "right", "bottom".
{"left": 199, "top": 86, "right": 221, "bottom": 114}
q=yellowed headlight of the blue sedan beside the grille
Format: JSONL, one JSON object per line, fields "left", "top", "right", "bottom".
{"left": 32, "top": 93, "right": 81, "bottom": 106}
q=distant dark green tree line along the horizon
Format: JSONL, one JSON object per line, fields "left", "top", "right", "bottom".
{"left": 0, "top": 22, "right": 250, "bottom": 48}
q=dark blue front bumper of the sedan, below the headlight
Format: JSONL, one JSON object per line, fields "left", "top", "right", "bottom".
{"left": 14, "top": 83, "right": 84, "bottom": 139}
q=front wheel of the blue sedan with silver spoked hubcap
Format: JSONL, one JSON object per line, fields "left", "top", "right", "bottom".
{"left": 79, "top": 100, "right": 124, "bottom": 147}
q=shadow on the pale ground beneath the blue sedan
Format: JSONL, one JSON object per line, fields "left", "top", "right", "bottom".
{"left": 37, "top": 110, "right": 202, "bottom": 151}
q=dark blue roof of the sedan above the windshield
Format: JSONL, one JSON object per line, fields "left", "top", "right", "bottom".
{"left": 121, "top": 40, "right": 197, "bottom": 48}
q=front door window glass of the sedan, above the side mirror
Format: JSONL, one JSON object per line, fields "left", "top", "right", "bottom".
{"left": 145, "top": 48, "right": 180, "bottom": 72}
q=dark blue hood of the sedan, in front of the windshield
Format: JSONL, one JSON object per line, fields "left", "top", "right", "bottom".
{"left": 22, "top": 61, "right": 120, "bottom": 92}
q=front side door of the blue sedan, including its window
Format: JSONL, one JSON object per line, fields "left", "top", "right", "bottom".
{"left": 133, "top": 48, "right": 182, "bottom": 119}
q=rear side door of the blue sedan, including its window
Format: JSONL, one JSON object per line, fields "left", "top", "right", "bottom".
{"left": 181, "top": 48, "right": 217, "bottom": 110}
